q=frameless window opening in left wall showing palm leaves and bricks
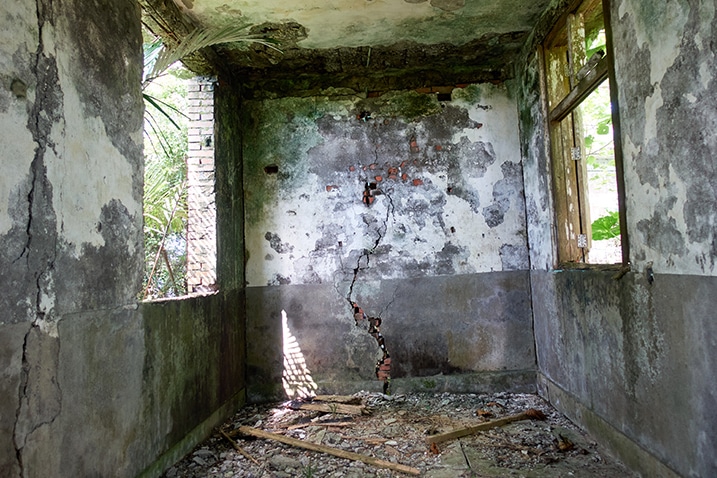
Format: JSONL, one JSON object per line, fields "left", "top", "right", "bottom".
{"left": 140, "top": 30, "right": 216, "bottom": 300}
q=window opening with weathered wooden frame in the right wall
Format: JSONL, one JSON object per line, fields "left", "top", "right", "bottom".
{"left": 544, "top": 0, "right": 624, "bottom": 264}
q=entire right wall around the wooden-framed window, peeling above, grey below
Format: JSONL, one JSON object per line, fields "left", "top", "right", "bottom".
{"left": 518, "top": 0, "right": 717, "bottom": 476}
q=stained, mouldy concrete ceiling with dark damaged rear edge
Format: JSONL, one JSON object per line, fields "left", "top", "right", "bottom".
{"left": 140, "top": 0, "right": 556, "bottom": 95}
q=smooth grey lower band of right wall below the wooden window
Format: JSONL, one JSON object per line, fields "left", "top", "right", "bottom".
{"left": 533, "top": 271, "right": 717, "bottom": 476}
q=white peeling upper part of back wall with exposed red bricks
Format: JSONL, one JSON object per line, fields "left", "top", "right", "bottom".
{"left": 244, "top": 85, "right": 528, "bottom": 288}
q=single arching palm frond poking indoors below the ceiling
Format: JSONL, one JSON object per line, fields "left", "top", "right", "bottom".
{"left": 149, "top": 25, "right": 281, "bottom": 78}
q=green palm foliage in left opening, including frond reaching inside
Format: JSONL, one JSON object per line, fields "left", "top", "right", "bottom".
{"left": 142, "top": 25, "right": 280, "bottom": 299}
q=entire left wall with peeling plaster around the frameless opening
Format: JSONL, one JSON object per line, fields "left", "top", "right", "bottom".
{"left": 0, "top": 0, "right": 244, "bottom": 477}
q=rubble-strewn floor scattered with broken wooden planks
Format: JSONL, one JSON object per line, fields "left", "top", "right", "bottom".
{"left": 165, "top": 392, "right": 634, "bottom": 478}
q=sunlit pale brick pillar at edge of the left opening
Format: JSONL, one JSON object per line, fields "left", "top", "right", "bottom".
{"left": 187, "top": 77, "right": 217, "bottom": 293}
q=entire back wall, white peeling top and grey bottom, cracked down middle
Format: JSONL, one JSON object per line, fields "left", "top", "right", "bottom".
{"left": 243, "top": 83, "right": 534, "bottom": 398}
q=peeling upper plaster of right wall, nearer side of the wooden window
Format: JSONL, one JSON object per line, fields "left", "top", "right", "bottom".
{"left": 612, "top": 0, "right": 717, "bottom": 276}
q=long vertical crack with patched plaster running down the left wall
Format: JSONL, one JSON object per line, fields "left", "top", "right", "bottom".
{"left": 13, "top": 2, "right": 63, "bottom": 474}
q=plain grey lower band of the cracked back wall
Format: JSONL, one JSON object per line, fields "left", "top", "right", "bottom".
{"left": 247, "top": 271, "right": 535, "bottom": 401}
